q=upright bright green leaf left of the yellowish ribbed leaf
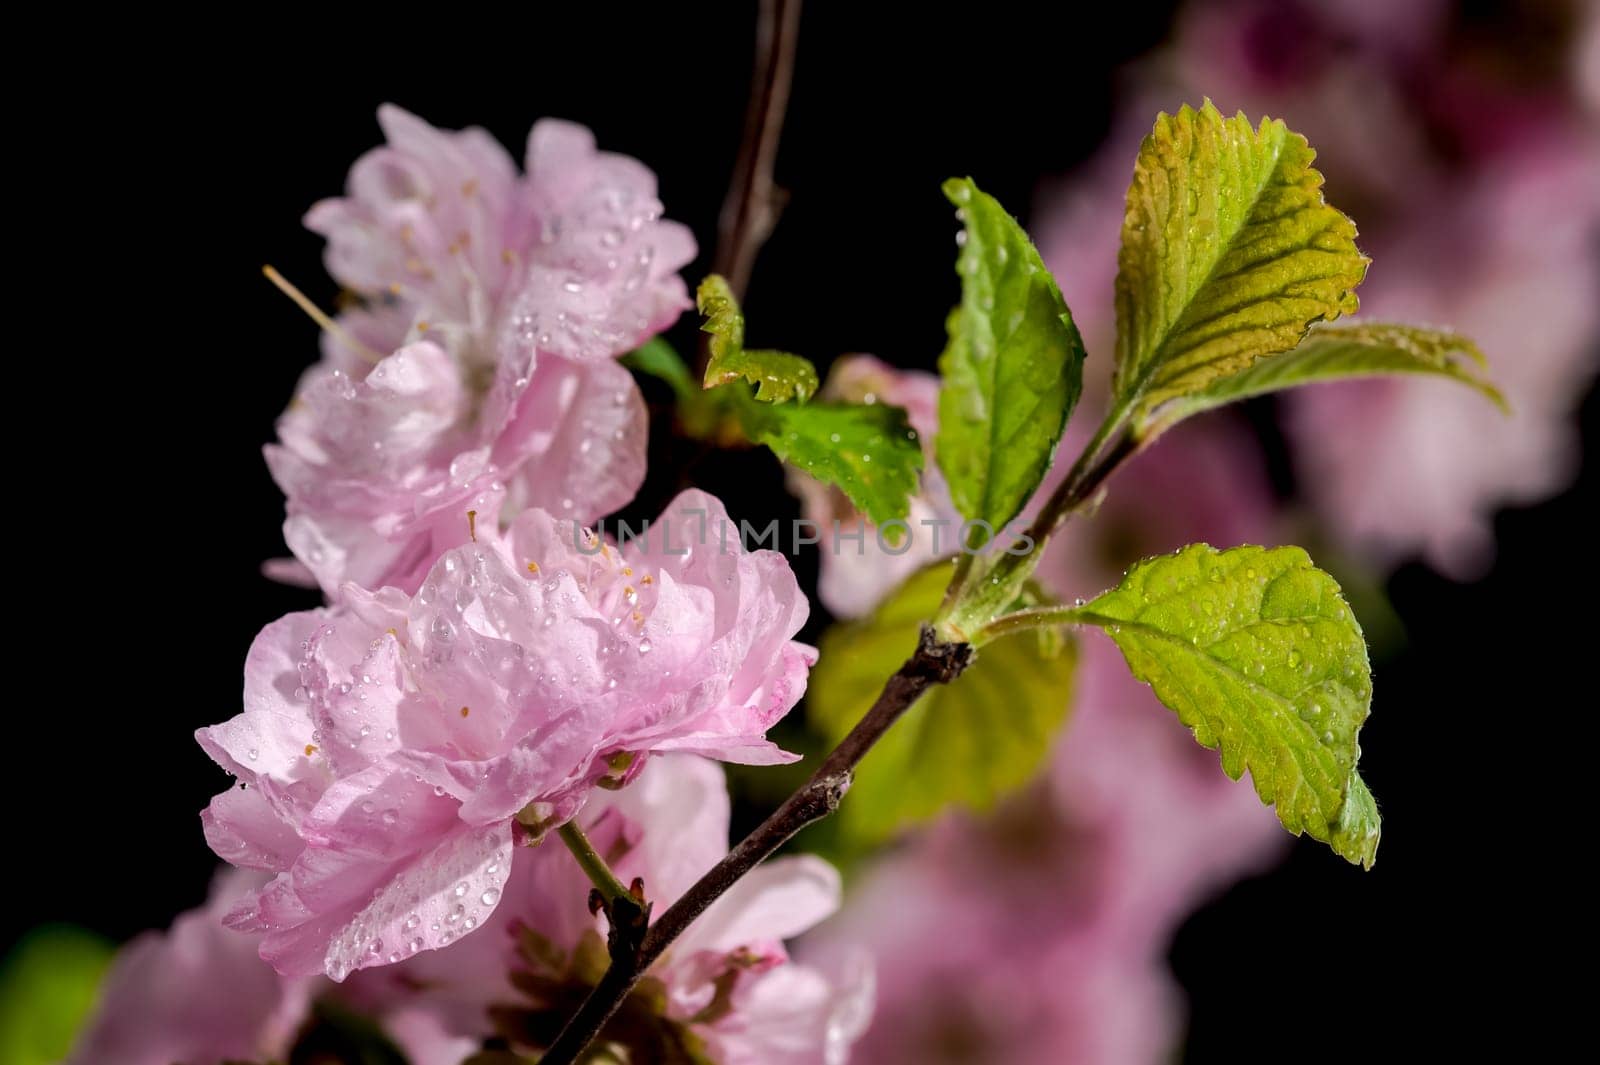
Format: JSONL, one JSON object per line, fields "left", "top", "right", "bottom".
{"left": 936, "top": 178, "right": 1083, "bottom": 529}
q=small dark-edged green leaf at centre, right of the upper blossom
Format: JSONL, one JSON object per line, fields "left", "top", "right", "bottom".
{"left": 725, "top": 391, "right": 922, "bottom": 525}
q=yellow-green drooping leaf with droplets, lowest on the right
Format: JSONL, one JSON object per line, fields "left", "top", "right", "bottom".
{"left": 1074, "top": 544, "right": 1379, "bottom": 868}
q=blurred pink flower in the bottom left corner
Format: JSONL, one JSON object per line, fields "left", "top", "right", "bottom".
{"left": 67, "top": 870, "right": 318, "bottom": 1065}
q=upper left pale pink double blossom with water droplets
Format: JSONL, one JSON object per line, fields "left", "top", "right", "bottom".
{"left": 267, "top": 106, "right": 694, "bottom": 596}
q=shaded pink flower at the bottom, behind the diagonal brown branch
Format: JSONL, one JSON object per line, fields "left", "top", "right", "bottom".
{"left": 347, "top": 755, "right": 872, "bottom": 1065}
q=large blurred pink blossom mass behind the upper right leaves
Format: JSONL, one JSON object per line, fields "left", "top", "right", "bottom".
{"left": 1035, "top": 0, "right": 1600, "bottom": 576}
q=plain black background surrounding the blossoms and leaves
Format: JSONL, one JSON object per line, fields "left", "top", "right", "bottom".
{"left": 18, "top": 3, "right": 1600, "bottom": 1062}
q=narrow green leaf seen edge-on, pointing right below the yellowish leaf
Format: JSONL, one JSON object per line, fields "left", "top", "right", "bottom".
{"left": 1160, "top": 321, "right": 1510, "bottom": 425}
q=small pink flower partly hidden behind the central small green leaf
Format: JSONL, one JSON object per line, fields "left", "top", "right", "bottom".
{"left": 787, "top": 355, "right": 962, "bottom": 617}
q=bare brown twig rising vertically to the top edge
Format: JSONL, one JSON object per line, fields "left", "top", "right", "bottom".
{"left": 712, "top": 0, "right": 800, "bottom": 299}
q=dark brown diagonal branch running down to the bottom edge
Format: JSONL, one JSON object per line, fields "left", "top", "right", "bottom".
{"left": 539, "top": 625, "right": 973, "bottom": 1065}
